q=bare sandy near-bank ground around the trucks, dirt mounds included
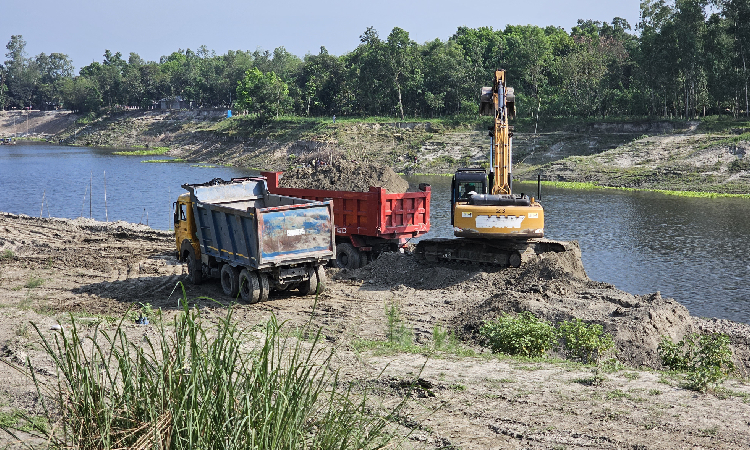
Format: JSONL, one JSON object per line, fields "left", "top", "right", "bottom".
{"left": 0, "top": 214, "right": 750, "bottom": 449}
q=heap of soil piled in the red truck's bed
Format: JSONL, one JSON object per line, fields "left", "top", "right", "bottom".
{"left": 279, "top": 159, "right": 409, "bottom": 194}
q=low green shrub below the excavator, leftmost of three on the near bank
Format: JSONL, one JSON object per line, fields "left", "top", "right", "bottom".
{"left": 479, "top": 311, "right": 555, "bottom": 357}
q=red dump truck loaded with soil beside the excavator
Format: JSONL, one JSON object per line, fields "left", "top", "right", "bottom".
{"left": 261, "top": 172, "right": 432, "bottom": 269}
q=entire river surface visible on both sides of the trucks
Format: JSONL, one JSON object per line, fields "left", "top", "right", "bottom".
{"left": 0, "top": 144, "right": 750, "bottom": 323}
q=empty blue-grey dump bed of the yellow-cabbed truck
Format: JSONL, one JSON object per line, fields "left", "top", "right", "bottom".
{"left": 182, "top": 178, "right": 335, "bottom": 269}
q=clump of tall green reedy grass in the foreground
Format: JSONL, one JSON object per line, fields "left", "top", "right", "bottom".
{"left": 20, "top": 294, "right": 402, "bottom": 450}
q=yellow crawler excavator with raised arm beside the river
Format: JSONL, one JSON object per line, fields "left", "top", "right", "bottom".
{"left": 414, "top": 70, "right": 565, "bottom": 267}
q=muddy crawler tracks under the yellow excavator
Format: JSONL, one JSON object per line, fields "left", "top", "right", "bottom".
{"left": 414, "top": 238, "right": 570, "bottom": 267}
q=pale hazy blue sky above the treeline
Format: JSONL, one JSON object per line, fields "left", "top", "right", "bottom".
{"left": 0, "top": 0, "right": 640, "bottom": 69}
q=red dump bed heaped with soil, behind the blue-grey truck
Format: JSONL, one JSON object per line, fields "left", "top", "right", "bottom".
{"left": 261, "top": 172, "right": 431, "bottom": 242}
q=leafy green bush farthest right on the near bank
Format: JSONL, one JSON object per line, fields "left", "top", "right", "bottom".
{"left": 658, "top": 333, "right": 735, "bottom": 392}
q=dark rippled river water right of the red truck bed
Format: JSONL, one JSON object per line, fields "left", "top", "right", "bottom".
{"left": 410, "top": 176, "right": 750, "bottom": 323}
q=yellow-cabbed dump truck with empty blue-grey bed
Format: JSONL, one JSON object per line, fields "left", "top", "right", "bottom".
{"left": 174, "top": 177, "right": 336, "bottom": 303}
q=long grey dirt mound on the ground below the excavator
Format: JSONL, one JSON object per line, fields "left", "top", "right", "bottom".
{"left": 336, "top": 245, "right": 708, "bottom": 368}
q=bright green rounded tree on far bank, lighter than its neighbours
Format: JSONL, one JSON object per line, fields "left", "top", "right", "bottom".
{"left": 237, "top": 68, "right": 290, "bottom": 122}
